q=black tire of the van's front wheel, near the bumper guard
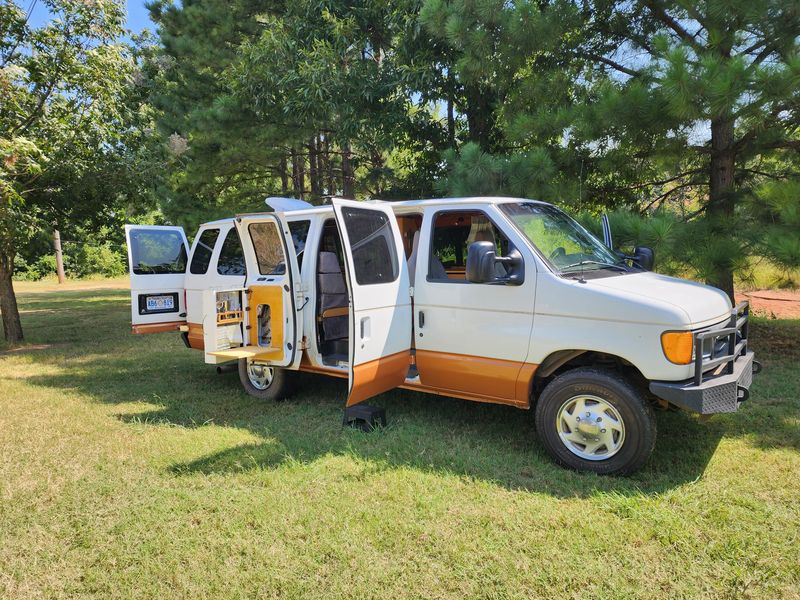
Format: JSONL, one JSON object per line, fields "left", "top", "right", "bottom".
{"left": 535, "top": 368, "right": 656, "bottom": 475}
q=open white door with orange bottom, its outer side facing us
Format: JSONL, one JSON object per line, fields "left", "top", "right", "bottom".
{"left": 331, "top": 200, "right": 411, "bottom": 406}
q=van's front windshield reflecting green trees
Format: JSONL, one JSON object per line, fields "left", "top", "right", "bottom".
{"left": 499, "top": 202, "right": 628, "bottom": 273}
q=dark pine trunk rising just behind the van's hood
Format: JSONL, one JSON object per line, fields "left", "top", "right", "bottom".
{"left": 706, "top": 118, "right": 736, "bottom": 303}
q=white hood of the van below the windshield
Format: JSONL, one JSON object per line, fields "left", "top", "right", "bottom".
{"left": 590, "top": 271, "right": 733, "bottom": 329}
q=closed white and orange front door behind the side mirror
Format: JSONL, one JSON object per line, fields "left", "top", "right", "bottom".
{"left": 414, "top": 205, "right": 536, "bottom": 405}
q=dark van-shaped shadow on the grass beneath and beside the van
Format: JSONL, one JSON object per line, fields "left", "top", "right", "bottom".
{"left": 23, "top": 344, "right": 744, "bottom": 497}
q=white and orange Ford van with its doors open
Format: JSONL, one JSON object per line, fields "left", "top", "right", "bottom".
{"left": 126, "top": 198, "right": 758, "bottom": 473}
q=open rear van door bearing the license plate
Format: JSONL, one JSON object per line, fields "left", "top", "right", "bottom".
{"left": 125, "top": 225, "right": 189, "bottom": 333}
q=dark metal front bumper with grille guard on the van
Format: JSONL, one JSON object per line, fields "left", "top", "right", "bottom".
{"left": 650, "top": 301, "right": 761, "bottom": 415}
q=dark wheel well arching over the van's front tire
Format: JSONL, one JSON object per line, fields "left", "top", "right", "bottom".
{"left": 531, "top": 350, "right": 651, "bottom": 404}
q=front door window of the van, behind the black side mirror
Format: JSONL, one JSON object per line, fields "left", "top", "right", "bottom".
{"left": 428, "top": 210, "right": 513, "bottom": 283}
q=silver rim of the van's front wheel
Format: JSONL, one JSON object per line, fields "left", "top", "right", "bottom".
{"left": 556, "top": 394, "right": 625, "bottom": 460}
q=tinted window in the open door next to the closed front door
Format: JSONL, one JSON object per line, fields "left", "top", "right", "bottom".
{"left": 342, "top": 206, "right": 399, "bottom": 285}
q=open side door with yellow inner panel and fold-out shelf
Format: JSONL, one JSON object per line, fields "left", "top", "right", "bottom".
{"left": 207, "top": 213, "right": 304, "bottom": 369}
